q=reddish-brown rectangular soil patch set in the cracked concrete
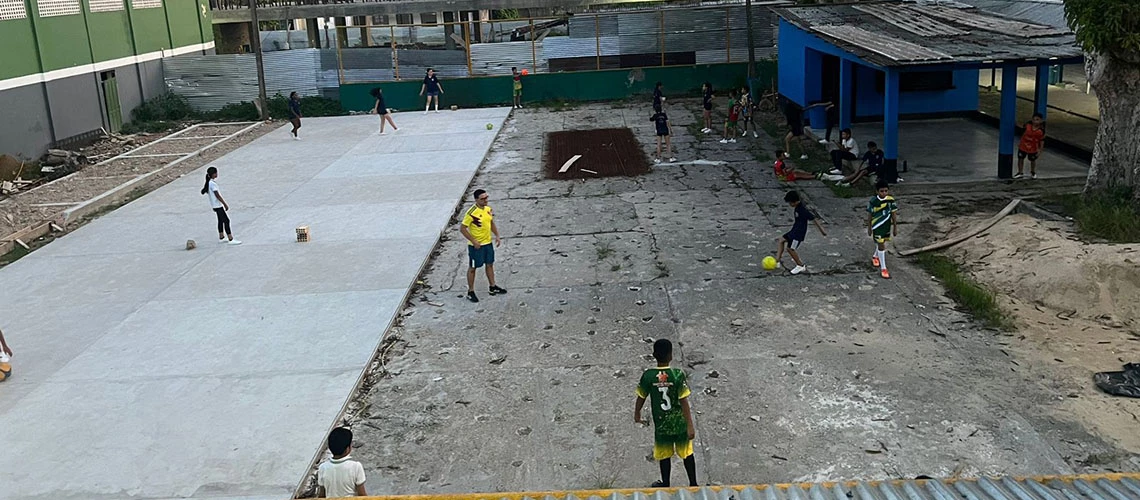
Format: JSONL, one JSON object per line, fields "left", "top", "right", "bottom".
{"left": 543, "top": 129, "right": 649, "bottom": 179}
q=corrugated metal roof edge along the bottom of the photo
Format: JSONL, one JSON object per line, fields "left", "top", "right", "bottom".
{"left": 342, "top": 474, "right": 1140, "bottom": 500}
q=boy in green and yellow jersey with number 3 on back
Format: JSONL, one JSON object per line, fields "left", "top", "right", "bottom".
{"left": 634, "top": 338, "right": 698, "bottom": 487}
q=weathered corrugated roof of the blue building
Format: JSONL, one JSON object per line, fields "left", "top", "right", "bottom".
{"left": 772, "top": 1, "right": 1083, "bottom": 66}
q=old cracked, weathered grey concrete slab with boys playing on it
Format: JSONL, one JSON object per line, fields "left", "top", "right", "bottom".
{"left": 350, "top": 98, "right": 1140, "bottom": 494}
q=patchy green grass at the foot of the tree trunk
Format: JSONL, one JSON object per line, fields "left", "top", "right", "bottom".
{"left": 1045, "top": 189, "right": 1140, "bottom": 243}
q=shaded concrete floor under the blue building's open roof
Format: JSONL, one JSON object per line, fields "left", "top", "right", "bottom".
{"left": 852, "top": 118, "right": 1089, "bottom": 182}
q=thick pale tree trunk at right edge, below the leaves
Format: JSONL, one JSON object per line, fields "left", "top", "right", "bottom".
{"left": 1084, "top": 54, "right": 1140, "bottom": 199}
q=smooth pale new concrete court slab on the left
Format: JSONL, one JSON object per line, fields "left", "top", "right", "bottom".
{"left": 0, "top": 108, "right": 510, "bottom": 499}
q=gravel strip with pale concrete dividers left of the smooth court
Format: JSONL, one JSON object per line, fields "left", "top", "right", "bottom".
{"left": 0, "top": 123, "right": 278, "bottom": 235}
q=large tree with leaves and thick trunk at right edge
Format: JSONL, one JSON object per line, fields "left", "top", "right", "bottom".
{"left": 1065, "top": 0, "right": 1140, "bottom": 199}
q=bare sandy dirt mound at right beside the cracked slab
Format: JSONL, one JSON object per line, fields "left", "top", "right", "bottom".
{"left": 941, "top": 214, "right": 1140, "bottom": 452}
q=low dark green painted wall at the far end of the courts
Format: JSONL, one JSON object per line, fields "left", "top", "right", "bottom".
{"left": 341, "top": 60, "right": 776, "bottom": 110}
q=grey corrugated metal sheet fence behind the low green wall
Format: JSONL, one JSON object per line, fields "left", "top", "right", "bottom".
{"left": 163, "top": 2, "right": 782, "bottom": 110}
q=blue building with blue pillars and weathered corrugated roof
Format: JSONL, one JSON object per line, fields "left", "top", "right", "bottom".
{"left": 773, "top": 1, "right": 1083, "bottom": 181}
